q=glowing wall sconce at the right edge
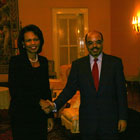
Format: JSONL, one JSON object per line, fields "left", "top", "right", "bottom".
{"left": 132, "top": 16, "right": 140, "bottom": 32}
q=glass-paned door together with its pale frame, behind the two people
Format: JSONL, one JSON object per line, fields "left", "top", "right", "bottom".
{"left": 52, "top": 8, "right": 88, "bottom": 78}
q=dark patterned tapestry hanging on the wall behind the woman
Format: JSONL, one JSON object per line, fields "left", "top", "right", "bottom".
{"left": 0, "top": 0, "right": 19, "bottom": 74}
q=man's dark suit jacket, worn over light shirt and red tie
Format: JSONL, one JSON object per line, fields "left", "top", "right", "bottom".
{"left": 55, "top": 54, "right": 127, "bottom": 133}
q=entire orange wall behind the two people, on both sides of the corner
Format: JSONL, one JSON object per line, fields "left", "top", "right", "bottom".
{"left": 0, "top": 0, "right": 140, "bottom": 80}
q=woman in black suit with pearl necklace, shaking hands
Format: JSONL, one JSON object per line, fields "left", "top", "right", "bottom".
{"left": 8, "top": 25, "right": 53, "bottom": 140}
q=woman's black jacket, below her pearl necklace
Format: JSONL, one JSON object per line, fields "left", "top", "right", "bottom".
{"left": 8, "top": 55, "right": 51, "bottom": 119}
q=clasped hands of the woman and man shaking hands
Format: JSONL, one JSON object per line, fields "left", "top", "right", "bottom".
{"left": 39, "top": 99, "right": 56, "bottom": 114}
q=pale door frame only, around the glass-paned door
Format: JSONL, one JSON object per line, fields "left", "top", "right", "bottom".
{"left": 52, "top": 8, "right": 88, "bottom": 78}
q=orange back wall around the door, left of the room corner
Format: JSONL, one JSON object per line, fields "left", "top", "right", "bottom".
{"left": 19, "top": 0, "right": 111, "bottom": 59}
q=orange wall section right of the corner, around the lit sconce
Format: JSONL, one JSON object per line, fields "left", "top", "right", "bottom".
{"left": 111, "top": 0, "right": 140, "bottom": 80}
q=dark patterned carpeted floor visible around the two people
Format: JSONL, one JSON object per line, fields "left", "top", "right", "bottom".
{"left": 0, "top": 109, "right": 140, "bottom": 140}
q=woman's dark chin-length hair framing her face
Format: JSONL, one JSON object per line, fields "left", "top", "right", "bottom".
{"left": 18, "top": 24, "right": 44, "bottom": 54}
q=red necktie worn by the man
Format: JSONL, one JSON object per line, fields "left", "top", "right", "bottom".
{"left": 92, "top": 58, "right": 99, "bottom": 91}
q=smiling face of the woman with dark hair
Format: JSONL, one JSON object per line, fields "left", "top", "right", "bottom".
{"left": 23, "top": 31, "right": 40, "bottom": 53}
